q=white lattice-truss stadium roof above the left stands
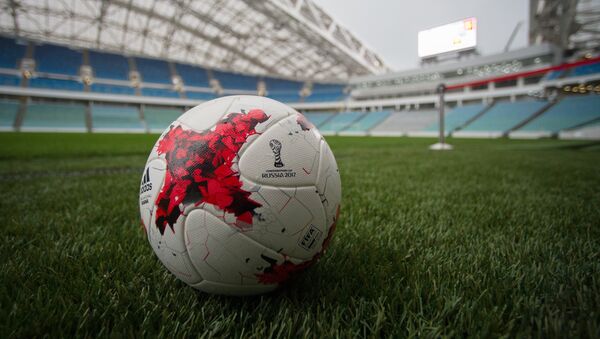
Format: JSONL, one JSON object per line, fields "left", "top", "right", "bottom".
{"left": 0, "top": 0, "right": 388, "bottom": 79}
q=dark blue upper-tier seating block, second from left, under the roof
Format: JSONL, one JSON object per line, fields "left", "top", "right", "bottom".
{"left": 34, "top": 45, "right": 82, "bottom": 75}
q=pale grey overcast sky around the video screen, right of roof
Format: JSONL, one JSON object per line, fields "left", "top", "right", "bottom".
{"left": 314, "top": 0, "right": 529, "bottom": 70}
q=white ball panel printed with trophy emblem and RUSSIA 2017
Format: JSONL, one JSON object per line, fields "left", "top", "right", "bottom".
{"left": 238, "top": 114, "right": 320, "bottom": 187}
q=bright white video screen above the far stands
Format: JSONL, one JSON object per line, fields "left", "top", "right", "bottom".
{"left": 418, "top": 18, "right": 477, "bottom": 58}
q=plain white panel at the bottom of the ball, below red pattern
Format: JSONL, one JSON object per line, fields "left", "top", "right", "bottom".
{"left": 185, "top": 209, "right": 284, "bottom": 286}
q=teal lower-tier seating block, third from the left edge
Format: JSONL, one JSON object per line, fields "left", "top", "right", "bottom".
{"left": 92, "top": 104, "right": 144, "bottom": 132}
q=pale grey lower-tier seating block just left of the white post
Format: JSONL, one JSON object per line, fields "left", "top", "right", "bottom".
{"left": 371, "top": 110, "right": 438, "bottom": 136}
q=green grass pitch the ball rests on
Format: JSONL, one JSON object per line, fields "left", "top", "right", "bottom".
{"left": 0, "top": 133, "right": 600, "bottom": 338}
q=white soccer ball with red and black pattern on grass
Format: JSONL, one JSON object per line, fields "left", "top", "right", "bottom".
{"left": 139, "top": 95, "right": 341, "bottom": 295}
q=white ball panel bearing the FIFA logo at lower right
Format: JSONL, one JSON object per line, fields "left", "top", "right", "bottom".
{"left": 243, "top": 185, "right": 329, "bottom": 261}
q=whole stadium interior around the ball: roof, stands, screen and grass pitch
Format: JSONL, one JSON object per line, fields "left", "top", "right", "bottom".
{"left": 0, "top": 0, "right": 600, "bottom": 338}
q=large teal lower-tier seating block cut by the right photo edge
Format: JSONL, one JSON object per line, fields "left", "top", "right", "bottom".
{"left": 509, "top": 95, "right": 600, "bottom": 138}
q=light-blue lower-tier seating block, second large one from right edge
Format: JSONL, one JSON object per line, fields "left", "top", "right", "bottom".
{"left": 452, "top": 100, "right": 548, "bottom": 137}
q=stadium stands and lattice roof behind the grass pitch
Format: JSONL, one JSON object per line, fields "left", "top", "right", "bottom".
{"left": 0, "top": 0, "right": 600, "bottom": 138}
